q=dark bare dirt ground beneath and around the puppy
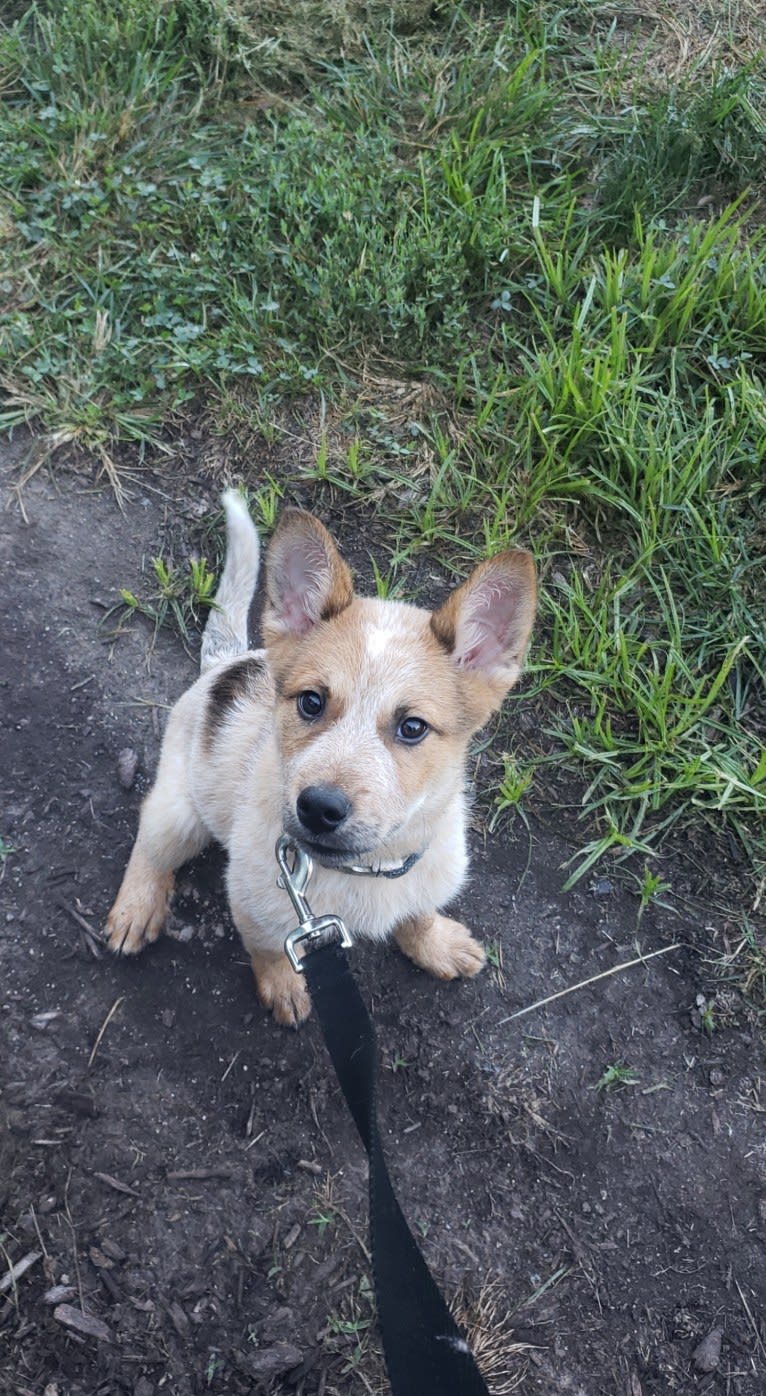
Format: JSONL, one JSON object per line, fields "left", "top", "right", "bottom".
{"left": 0, "top": 438, "right": 766, "bottom": 1396}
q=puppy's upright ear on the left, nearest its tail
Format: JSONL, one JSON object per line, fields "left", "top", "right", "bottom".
{"left": 262, "top": 510, "right": 353, "bottom": 645}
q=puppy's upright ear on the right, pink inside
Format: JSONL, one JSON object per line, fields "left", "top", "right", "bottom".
{"left": 431, "top": 549, "right": 537, "bottom": 725}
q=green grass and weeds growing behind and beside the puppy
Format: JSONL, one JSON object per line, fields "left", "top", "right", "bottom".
{"left": 0, "top": 0, "right": 766, "bottom": 909}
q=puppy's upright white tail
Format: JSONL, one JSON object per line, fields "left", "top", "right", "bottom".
{"left": 200, "top": 490, "right": 261, "bottom": 673}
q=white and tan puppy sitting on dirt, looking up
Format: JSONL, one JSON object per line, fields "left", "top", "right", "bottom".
{"left": 106, "top": 490, "right": 536, "bottom": 1026}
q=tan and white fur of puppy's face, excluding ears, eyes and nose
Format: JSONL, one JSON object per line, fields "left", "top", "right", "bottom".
{"left": 269, "top": 600, "right": 467, "bottom": 846}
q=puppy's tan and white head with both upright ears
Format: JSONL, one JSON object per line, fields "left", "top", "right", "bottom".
{"left": 262, "top": 510, "right": 536, "bottom": 866}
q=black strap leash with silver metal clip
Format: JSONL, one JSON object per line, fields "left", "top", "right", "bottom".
{"left": 278, "top": 840, "right": 488, "bottom": 1396}
